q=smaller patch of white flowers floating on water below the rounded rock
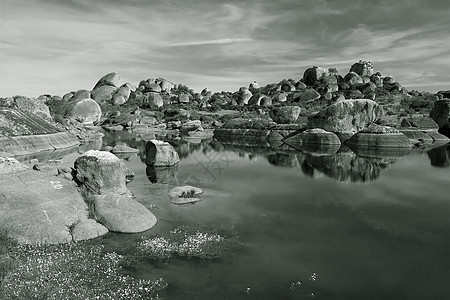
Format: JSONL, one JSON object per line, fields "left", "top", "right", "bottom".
{"left": 136, "top": 225, "right": 242, "bottom": 260}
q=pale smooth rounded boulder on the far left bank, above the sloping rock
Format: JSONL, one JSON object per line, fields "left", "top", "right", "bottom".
{"left": 64, "top": 98, "right": 102, "bottom": 123}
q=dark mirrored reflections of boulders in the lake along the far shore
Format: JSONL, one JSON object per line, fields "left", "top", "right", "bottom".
{"left": 103, "top": 133, "right": 450, "bottom": 183}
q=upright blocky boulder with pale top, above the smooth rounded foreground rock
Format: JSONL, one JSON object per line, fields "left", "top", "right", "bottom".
{"left": 74, "top": 150, "right": 128, "bottom": 195}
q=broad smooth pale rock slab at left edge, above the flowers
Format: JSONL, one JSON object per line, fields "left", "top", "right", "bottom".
{"left": 0, "top": 169, "right": 108, "bottom": 244}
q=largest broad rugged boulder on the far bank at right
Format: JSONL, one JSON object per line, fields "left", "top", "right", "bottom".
{"left": 307, "top": 99, "right": 383, "bottom": 135}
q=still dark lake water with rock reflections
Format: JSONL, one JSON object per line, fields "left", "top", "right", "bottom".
{"left": 84, "top": 133, "right": 450, "bottom": 300}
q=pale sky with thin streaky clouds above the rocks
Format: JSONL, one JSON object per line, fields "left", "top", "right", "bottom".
{"left": 0, "top": 0, "right": 450, "bottom": 97}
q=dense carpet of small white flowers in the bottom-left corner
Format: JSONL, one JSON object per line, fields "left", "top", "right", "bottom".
{"left": 1, "top": 243, "right": 167, "bottom": 300}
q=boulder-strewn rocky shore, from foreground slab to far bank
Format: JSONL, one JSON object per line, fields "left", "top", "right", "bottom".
{"left": 0, "top": 61, "right": 450, "bottom": 243}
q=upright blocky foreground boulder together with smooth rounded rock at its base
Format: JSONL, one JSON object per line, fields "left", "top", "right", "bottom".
{"left": 74, "top": 150, "right": 157, "bottom": 233}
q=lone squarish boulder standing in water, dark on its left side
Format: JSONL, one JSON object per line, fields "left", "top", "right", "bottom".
{"left": 145, "top": 140, "right": 180, "bottom": 167}
